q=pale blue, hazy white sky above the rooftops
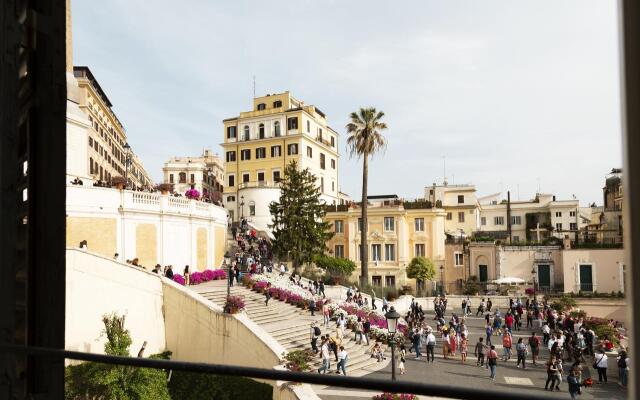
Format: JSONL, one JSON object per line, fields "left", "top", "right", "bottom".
{"left": 72, "top": 0, "right": 622, "bottom": 206}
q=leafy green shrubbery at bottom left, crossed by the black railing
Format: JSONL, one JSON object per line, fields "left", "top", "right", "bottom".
{"left": 65, "top": 314, "right": 170, "bottom": 400}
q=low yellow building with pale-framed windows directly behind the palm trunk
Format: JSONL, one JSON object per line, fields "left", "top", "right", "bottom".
{"left": 325, "top": 195, "right": 446, "bottom": 287}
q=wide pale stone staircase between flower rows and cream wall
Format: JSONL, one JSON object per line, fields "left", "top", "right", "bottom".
{"left": 191, "top": 281, "right": 388, "bottom": 376}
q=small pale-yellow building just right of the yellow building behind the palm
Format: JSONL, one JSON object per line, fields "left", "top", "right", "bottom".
{"left": 424, "top": 180, "right": 478, "bottom": 237}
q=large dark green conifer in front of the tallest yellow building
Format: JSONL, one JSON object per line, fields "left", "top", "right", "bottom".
{"left": 269, "top": 161, "right": 333, "bottom": 272}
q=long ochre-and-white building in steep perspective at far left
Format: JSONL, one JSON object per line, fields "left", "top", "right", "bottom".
{"left": 67, "top": 66, "right": 153, "bottom": 188}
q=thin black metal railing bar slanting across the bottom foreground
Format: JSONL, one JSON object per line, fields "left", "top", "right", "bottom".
{"left": 0, "top": 344, "right": 540, "bottom": 400}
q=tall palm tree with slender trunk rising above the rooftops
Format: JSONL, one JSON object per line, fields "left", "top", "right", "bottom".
{"left": 346, "top": 107, "right": 387, "bottom": 287}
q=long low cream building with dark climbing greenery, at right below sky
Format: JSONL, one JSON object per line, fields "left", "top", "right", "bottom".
{"left": 478, "top": 193, "right": 590, "bottom": 242}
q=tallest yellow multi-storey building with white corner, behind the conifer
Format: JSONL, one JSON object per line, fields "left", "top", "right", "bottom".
{"left": 221, "top": 92, "right": 339, "bottom": 231}
